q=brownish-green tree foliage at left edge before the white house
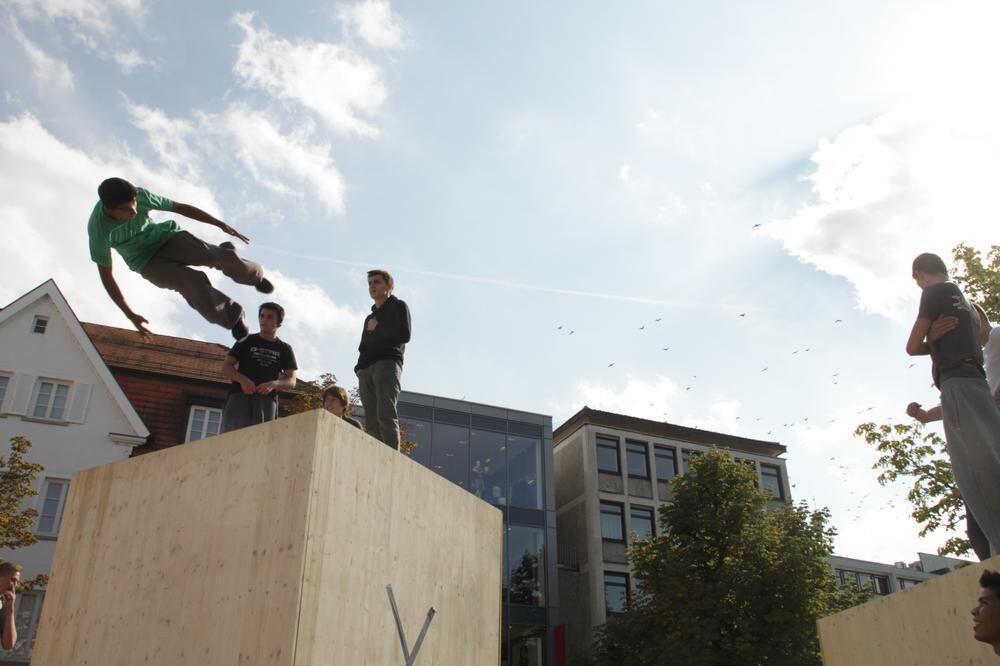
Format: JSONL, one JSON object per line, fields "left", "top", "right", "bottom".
{"left": 0, "top": 436, "right": 48, "bottom": 592}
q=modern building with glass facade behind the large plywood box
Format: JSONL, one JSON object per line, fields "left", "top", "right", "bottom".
{"left": 362, "top": 391, "right": 559, "bottom": 666}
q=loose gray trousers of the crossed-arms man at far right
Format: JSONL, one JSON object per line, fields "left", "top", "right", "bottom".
{"left": 941, "top": 377, "right": 1000, "bottom": 555}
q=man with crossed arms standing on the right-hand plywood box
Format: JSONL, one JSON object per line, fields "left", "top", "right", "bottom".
{"left": 906, "top": 253, "right": 1000, "bottom": 555}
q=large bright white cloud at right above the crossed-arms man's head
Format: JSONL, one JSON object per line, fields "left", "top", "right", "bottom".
{"left": 762, "top": 104, "right": 1000, "bottom": 316}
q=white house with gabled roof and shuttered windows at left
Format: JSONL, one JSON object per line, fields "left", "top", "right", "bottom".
{"left": 0, "top": 280, "right": 149, "bottom": 665}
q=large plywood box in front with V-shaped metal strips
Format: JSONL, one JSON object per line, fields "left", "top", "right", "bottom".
{"left": 33, "top": 410, "right": 503, "bottom": 666}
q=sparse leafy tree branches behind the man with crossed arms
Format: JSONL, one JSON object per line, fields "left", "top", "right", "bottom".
{"left": 854, "top": 244, "right": 1000, "bottom": 557}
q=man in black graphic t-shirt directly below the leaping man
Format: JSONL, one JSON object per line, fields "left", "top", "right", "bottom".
{"left": 222, "top": 303, "right": 298, "bottom": 432}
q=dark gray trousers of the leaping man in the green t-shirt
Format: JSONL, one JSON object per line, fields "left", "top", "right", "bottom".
{"left": 140, "top": 231, "right": 264, "bottom": 328}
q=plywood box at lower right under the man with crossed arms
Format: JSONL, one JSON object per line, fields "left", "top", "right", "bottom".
{"left": 819, "top": 557, "right": 1000, "bottom": 666}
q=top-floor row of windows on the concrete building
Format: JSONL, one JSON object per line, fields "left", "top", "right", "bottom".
{"left": 597, "top": 435, "right": 784, "bottom": 499}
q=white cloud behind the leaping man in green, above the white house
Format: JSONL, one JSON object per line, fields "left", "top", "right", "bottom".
{"left": 0, "top": 114, "right": 218, "bottom": 334}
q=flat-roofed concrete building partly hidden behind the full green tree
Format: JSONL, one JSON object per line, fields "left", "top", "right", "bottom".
{"left": 553, "top": 407, "right": 790, "bottom": 660}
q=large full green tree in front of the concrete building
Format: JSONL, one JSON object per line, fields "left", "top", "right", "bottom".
{"left": 595, "top": 450, "right": 867, "bottom": 666}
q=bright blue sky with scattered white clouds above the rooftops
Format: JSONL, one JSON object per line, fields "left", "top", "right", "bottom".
{"left": 0, "top": 0, "right": 1000, "bottom": 561}
